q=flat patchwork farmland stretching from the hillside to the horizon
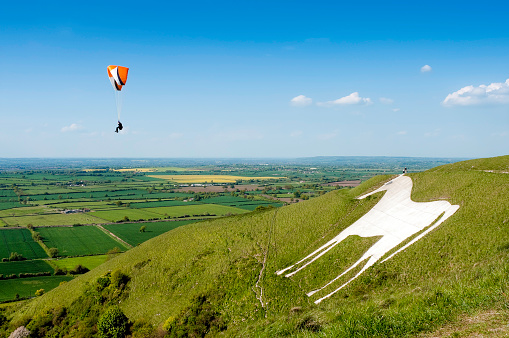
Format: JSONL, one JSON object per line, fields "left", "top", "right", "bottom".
{"left": 0, "top": 158, "right": 432, "bottom": 302}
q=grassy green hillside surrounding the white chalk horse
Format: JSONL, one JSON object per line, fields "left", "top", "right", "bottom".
{"left": 0, "top": 156, "right": 509, "bottom": 337}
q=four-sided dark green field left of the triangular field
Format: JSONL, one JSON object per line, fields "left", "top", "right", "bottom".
{"left": 37, "top": 226, "right": 127, "bottom": 256}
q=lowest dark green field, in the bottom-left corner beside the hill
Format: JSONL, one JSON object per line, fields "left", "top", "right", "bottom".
{"left": 0, "top": 276, "right": 72, "bottom": 302}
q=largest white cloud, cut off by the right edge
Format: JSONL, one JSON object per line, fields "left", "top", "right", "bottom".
{"left": 442, "top": 79, "right": 509, "bottom": 106}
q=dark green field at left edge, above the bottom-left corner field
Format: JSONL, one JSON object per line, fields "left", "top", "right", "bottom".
{"left": 0, "top": 229, "right": 48, "bottom": 259}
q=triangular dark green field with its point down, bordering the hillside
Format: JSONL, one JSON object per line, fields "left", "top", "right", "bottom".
{"left": 103, "top": 220, "right": 196, "bottom": 246}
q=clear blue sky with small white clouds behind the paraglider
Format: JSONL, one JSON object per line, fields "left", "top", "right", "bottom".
{"left": 0, "top": 1, "right": 509, "bottom": 157}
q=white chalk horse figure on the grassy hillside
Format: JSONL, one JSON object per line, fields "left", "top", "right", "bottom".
{"left": 277, "top": 175, "right": 459, "bottom": 304}
